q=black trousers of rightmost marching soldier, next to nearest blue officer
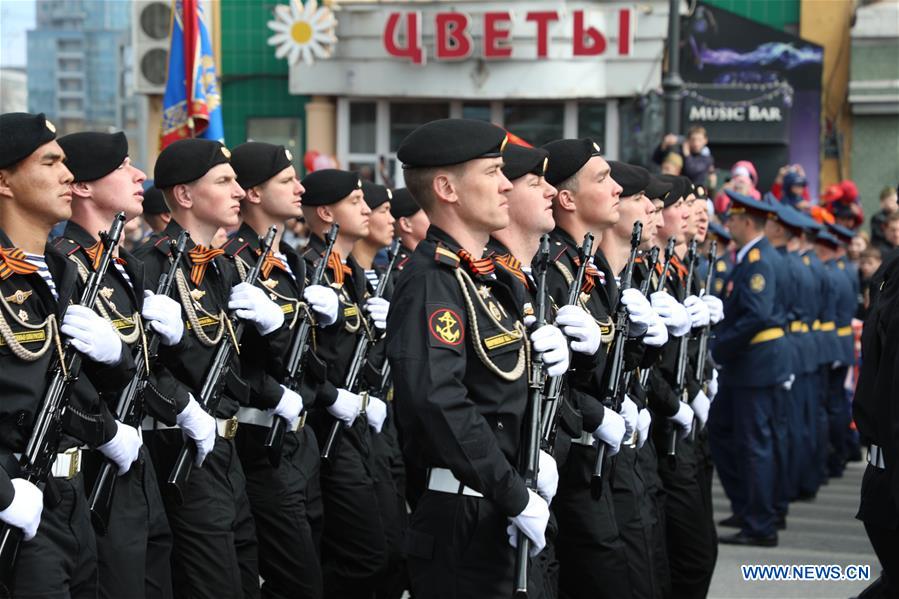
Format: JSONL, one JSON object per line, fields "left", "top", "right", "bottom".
{"left": 656, "top": 435, "right": 718, "bottom": 599}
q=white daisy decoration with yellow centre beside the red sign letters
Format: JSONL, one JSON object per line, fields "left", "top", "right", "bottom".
{"left": 268, "top": 0, "right": 337, "bottom": 65}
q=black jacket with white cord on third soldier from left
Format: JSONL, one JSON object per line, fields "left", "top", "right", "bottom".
{"left": 135, "top": 220, "right": 251, "bottom": 424}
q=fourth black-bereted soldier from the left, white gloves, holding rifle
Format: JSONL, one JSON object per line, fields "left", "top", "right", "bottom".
{"left": 223, "top": 142, "right": 337, "bottom": 599}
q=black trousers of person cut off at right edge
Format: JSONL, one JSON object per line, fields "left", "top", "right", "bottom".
{"left": 856, "top": 464, "right": 899, "bottom": 599}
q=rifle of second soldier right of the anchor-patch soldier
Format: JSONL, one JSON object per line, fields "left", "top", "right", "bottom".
{"left": 590, "top": 221, "right": 643, "bottom": 499}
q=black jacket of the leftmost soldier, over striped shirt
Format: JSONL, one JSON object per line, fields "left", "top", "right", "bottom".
{"left": 0, "top": 230, "right": 134, "bottom": 509}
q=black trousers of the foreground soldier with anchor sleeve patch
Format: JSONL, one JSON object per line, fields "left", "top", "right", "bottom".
{"left": 405, "top": 491, "right": 539, "bottom": 599}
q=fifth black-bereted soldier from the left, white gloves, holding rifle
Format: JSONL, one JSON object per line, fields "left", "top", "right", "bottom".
{"left": 303, "top": 169, "right": 389, "bottom": 597}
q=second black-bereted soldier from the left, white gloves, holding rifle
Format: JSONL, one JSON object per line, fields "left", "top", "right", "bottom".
{"left": 54, "top": 132, "right": 178, "bottom": 599}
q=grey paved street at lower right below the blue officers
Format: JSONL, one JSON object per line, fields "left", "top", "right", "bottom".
{"left": 709, "top": 463, "right": 879, "bottom": 599}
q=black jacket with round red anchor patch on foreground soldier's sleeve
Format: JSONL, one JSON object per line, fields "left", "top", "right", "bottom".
{"left": 387, "top": 225, "right": 529, "bottom": 517}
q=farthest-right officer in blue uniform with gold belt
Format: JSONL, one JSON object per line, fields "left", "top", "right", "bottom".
{"left": 815, "top": 231, "right": 856, "bottom": 477}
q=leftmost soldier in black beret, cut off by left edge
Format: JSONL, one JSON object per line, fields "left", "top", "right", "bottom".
{"left": 0, "top": 113, "right": 134, "bottom": 597}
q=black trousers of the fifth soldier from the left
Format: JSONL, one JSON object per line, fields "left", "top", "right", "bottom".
{"left": 319, "top": 418, "right": 389, "bottom": 599}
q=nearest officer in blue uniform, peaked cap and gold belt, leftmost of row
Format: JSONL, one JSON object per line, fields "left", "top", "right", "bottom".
{"left": 709, "top": 192, "right": 791, "bottom": 547}
